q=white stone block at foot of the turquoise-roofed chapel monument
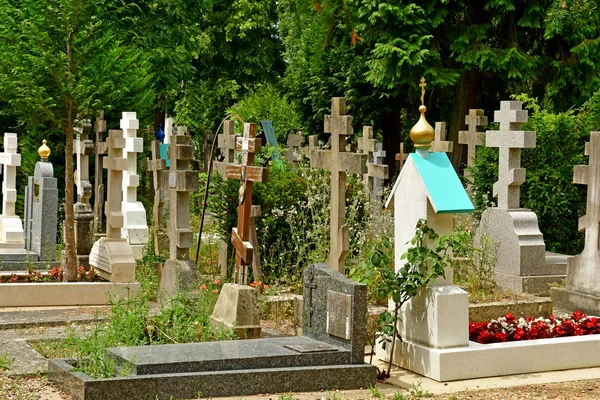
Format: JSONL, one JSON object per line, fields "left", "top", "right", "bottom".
{"left": 398, "top": 285, "right": 469, "bottom": 348}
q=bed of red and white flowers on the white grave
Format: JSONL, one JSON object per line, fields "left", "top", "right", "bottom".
{"left": 469, "top": 311, "right": 600, "bottom": 344}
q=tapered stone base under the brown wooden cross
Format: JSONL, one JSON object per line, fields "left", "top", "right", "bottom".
{"left": 210, "top": 283, "right": 261, "bottom": 339}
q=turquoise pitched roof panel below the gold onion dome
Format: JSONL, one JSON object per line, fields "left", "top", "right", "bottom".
{"left": 408, "top": 152, "right": 475, "bottom": 214}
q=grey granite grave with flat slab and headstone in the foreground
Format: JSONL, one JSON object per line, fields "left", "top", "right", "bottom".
{"left": 48, "top": 264, "right": 376, "bottom": 400}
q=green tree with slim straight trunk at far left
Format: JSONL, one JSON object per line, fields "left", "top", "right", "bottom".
{"left": 0, "top": 0, "right": 155, "bottom": 280}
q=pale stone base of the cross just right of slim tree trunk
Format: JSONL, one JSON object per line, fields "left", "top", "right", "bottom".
{"left": 90, "top": 238, "right": 135, "bottom": 282}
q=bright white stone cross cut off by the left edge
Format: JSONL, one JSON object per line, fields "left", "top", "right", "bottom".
{"left": 0, "top": 133, "right": 25, "bottom": 249}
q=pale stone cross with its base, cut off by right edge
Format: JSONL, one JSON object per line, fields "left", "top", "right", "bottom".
{"left": 551, "top": 132, "right": 600, "bottom": 315}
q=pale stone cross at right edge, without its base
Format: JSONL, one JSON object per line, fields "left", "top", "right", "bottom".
{"left": 573, "top": 132, "right": 600, "bottom": 255}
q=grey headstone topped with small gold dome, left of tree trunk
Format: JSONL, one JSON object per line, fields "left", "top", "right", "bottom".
{"left": 25, "top": 140, "right": 58, "bottom": 262}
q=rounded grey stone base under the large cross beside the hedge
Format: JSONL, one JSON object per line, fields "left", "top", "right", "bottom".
{"left": 477, "top": 207, "right": 566, "bottom": 294}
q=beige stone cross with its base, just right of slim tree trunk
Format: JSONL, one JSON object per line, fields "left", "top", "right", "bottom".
{"left": 90, "top": 130, "right": 135, "bottom": 282}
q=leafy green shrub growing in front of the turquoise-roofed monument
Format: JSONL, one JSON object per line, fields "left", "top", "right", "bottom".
{"left": 371, "top": 219, "right": 469, "bottom": 378}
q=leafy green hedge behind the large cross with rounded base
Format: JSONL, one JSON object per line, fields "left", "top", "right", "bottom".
{"left": 473, "top": 93, "right": 600, "bottom": 254}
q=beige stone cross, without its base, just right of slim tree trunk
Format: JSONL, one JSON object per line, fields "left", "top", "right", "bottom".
{"left": 104, "top": 129, "right": 127, "bottom": 239}
